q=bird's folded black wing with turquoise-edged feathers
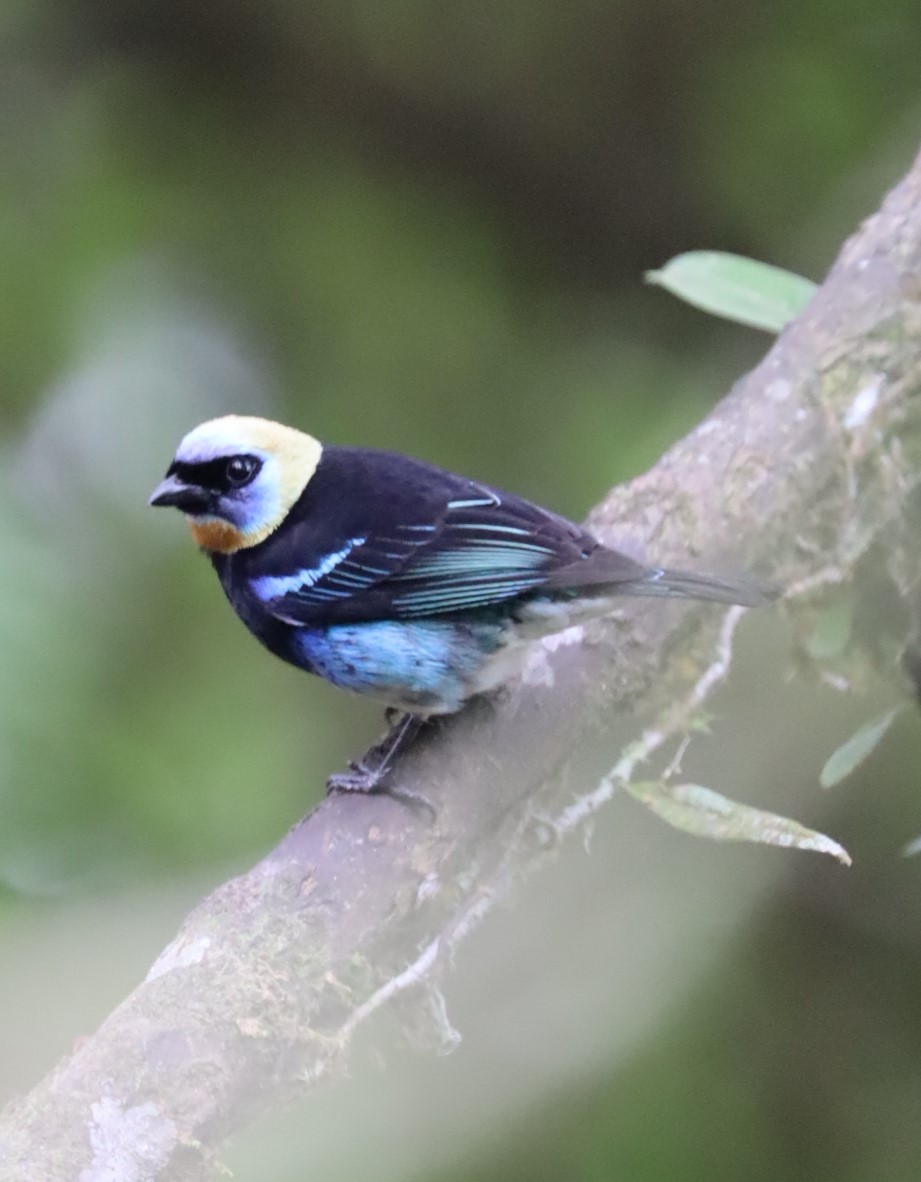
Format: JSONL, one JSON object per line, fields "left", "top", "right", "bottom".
{"left": 243, "top": 448, "right": 647, "bottom": 625}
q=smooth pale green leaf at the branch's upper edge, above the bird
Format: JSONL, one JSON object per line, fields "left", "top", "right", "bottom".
{"left": 646, "top": 251, "right": 816, "bottom": 332}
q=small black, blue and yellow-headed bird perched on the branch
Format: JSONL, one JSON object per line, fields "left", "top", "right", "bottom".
{"left": 149, "top": 415, "right": 777, "bottom": 792}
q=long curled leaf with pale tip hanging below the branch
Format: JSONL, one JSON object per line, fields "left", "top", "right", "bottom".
{"left": 627, "top": 780, "right": 851, "bottom": 866}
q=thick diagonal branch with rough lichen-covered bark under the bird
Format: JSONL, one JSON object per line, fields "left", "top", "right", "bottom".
{"left": 0, "top": 150, "right": 921, "bottom": 1182}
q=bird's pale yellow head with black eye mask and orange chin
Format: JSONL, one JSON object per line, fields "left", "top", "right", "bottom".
{"left": 150, "top": 415, "right": 323, "bottom": 554}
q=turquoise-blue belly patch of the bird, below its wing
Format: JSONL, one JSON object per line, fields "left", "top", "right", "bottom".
{"left": 293, "top": 619, "right": 502, "bottom": 712}
